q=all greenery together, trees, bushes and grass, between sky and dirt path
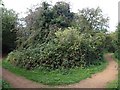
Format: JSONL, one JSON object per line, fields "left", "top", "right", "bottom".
{"left": 2, "top": 1, "right": 120, "bottom": 87}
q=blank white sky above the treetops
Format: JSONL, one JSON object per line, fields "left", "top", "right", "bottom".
{"left": 3, "top": 0, "right": 119, "bottom": 31}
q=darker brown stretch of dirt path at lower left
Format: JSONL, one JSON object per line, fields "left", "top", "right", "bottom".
{"left": 2, "top": 69, "right": 45, "bottom": 88}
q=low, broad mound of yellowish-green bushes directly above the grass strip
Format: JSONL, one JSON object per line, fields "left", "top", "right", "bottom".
{"left": 7, "top": 28, "right": 105, "bottom": 70}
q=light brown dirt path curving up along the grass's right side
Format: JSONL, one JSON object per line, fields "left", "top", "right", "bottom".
{"left": 56, "top": 54, "right": 118, "bottom": 88}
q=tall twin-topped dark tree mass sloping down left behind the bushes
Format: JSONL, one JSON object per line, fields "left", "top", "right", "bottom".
{"left": 19, "top": 2, "right": 74, "bottom": 47}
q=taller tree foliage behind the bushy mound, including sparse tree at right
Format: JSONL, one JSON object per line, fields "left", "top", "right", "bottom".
{"left": 17, "top": 1, "right": 108, "bottom": 49}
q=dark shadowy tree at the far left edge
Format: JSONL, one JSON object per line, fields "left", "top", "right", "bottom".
{"left": 2, "top": 8, "right": 17, "bottom": 53}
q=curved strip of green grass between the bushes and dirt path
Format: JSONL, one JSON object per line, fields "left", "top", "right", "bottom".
{"left": 3, "top": 60, "right": 107, "bottom": 85}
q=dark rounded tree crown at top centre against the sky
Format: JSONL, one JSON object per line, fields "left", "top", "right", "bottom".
{"left": 52, "top": 1, "right": 74, "bottom": 28}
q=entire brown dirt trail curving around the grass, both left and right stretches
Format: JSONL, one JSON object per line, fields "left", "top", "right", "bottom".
{"left": 2, "top": 54, "right": 118, "bottom": 88}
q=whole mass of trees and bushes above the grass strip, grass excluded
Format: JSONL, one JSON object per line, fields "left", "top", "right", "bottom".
{"left": 2, "top": 2, "right": 117, "bottom": 70}
